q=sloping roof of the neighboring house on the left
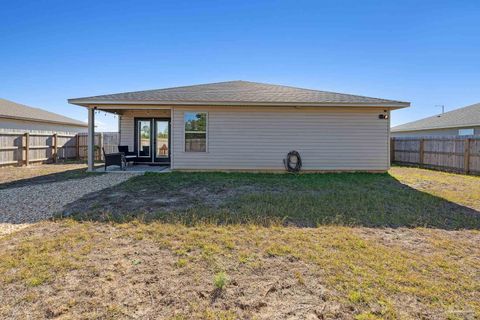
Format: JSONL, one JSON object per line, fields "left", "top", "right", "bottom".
{"left": 0, "top": 98, "right": 88, "bottom": 127}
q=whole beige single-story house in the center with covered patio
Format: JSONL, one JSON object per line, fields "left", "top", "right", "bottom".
{"left": 68, "top": 81, "right": 410, "bottom": 171}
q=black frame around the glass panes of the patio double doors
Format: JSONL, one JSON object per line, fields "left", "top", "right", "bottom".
{"left": 134, "top": 117, "right": 172, "bottom": 164}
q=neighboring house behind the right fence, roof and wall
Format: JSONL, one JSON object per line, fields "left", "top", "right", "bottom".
{"left": 392, "top": 103, "right": 480, "bottom": 137}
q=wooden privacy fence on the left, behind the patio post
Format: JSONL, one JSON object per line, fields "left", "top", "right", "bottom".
{"left": 0, "top": 132, "right": 118, "bottom": 166}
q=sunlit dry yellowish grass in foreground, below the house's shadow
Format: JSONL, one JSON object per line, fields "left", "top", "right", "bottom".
{"left": 0, "top": 221, "right": 480, "bottom": 319}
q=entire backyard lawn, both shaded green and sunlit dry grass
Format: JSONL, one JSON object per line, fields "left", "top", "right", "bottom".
{"left": 0, "top": 168, "right": 480, "bottom": 320}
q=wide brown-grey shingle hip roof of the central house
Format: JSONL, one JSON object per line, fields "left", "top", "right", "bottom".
{"left": 68, "top": 81, "right": 410, "bottom": 108}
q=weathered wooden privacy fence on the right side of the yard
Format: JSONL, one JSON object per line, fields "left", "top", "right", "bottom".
{"left": 390, "top": 136, "right": 480, "bottom": 174}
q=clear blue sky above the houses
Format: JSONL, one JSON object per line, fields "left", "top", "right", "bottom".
{"left": 0, "top": 0, "right": 480, "bottom": 130}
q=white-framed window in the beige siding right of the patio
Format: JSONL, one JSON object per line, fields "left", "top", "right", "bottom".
{"left": 183, "top": 112, "right": 207, "bottom": 152}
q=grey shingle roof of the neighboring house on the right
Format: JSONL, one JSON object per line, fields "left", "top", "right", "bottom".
{"left": 391, "top": 103, "right": 480, "bottom": 132}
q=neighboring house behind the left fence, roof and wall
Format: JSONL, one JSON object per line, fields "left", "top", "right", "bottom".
{"left": 0, "top": 99, "right": 88, "bottom": 133}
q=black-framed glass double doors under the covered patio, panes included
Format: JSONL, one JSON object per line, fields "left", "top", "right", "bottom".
{"left": 135, "top": 118, "right": 170, "bottom": 163}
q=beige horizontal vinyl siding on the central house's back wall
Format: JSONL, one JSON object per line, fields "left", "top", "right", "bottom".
{"left": 172, "top": 107, "right": 389, "bottom": 171}
